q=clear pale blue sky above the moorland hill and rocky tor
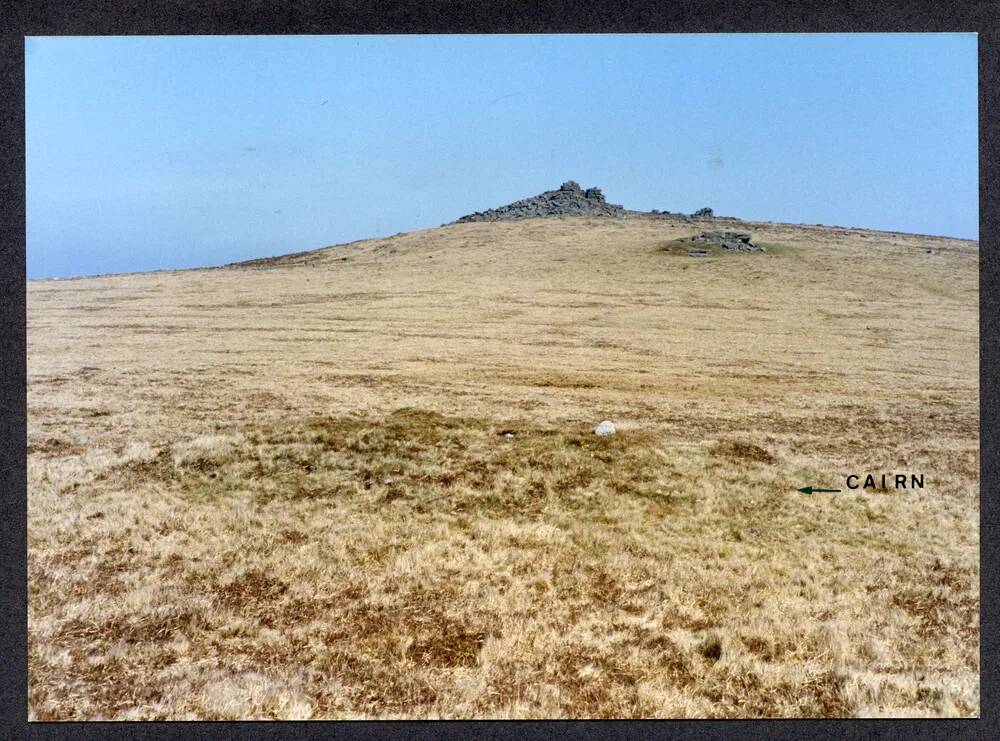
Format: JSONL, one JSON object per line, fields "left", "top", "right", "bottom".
{"left": 25, "top": 34, "right": 978, "bottom": 278}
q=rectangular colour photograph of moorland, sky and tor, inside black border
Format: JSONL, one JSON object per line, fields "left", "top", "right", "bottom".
{"left": 19, "top": 32, "right": 987, "bottom": 723}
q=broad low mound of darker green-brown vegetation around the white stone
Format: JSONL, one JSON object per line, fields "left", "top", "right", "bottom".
{"left": 107, "top": 408, "right": 675, "bottom": 516}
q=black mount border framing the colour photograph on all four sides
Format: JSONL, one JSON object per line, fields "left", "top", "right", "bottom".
{"left": 0, "top": 0, "right": 1000, "bottom": 741}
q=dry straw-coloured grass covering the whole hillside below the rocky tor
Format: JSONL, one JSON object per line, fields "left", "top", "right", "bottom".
{"left": 28, "top": 212, "right": 979, "bottom": 720}
